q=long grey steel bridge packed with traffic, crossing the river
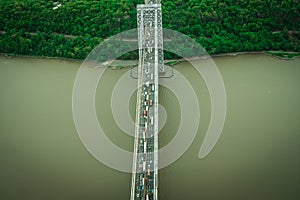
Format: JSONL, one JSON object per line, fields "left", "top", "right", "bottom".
{"left": 131, "top": 0, "right": 165, "bottom": 200}
